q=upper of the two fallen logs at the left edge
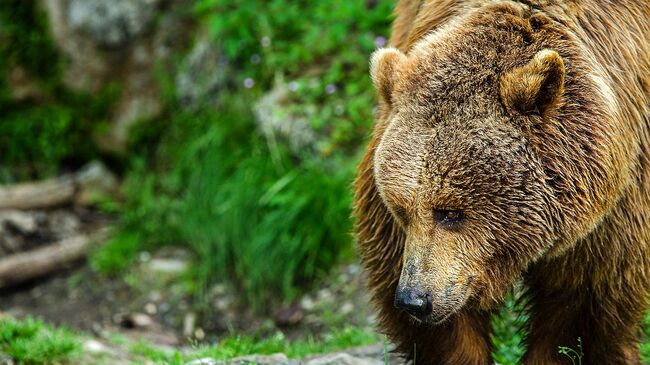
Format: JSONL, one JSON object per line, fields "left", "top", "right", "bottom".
{"left": 0, "top": 162, "right": 117, "bottom": 210}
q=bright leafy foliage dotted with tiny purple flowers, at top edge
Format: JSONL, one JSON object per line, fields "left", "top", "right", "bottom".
{"left": 196, "top": 0, "right": 395, "bottom": 152}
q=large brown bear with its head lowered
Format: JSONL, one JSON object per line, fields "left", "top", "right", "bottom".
{"left": 353, "top": 0, "right": 650, "bottom": 365}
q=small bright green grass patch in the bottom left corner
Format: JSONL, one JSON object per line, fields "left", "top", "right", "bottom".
{"left": 0, "top": 317, "right": 80, "bottom": 365}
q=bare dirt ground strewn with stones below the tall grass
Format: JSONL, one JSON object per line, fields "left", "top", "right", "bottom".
{"left": 0, "top": 248, "right": 373, "bottom": 347}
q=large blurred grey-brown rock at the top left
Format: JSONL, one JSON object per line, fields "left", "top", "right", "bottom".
{"left": 41, "top": 0, "right": 193, "bottom": 153}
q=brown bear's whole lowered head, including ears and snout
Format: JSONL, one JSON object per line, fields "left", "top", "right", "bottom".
{"left": 371, "top": 7, "right": 607, "bottom": 323}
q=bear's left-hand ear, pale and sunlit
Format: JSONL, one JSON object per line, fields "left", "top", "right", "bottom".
{"left": 370, "top": 48, "right": 406, "bottom": 105}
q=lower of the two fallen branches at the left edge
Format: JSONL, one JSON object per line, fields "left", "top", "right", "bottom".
{"left": 0, "top": 228, "right": 109, "bottom": 288}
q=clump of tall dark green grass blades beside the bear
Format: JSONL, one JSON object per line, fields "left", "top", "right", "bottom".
{"left": 179, "top": 106, "right": 351, "bottom": 307}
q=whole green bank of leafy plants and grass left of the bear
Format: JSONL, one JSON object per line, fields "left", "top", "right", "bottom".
{"left": 93, "top": 0, "right": 394, "bottom": 309}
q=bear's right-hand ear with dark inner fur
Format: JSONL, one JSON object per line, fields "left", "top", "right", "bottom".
{"left": 500, "top": 49, "right": 565, "bottom": 114}
